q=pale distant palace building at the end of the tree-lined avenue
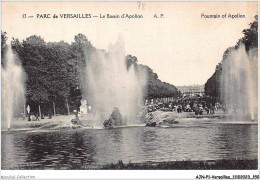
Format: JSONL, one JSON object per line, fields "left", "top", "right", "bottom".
{"left": 176, "top": 84, "right": 205, "bottom": 95}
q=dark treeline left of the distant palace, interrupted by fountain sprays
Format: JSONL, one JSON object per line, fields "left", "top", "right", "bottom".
{"left": 1, "top": 32, "right": 177, "bottom": 114}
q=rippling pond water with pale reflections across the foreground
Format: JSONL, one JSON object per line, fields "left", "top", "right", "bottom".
{"left": 1, "top": 120, "right": 258, "bottom": 169}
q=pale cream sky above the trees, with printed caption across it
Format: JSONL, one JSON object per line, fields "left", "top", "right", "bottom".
{"left": 2, "top": 2, "right": 258, "bottom": 86}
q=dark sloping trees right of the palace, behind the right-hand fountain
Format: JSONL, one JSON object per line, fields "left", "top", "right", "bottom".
{"left": 205, "top": 15, "right": 258, "bottom": 102}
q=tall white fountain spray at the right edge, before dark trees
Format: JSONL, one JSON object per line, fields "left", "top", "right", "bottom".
{"left": 220, "top": 44, "right": 258, "bottom": 120}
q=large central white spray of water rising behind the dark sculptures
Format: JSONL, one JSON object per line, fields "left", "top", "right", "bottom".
{"left": 86, "top": 36, "right": 146, "bottom": 126}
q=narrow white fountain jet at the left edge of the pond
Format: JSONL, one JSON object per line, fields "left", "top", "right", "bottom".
{"left": 1, "top": 46, "right": 25, "bottom": 130}
